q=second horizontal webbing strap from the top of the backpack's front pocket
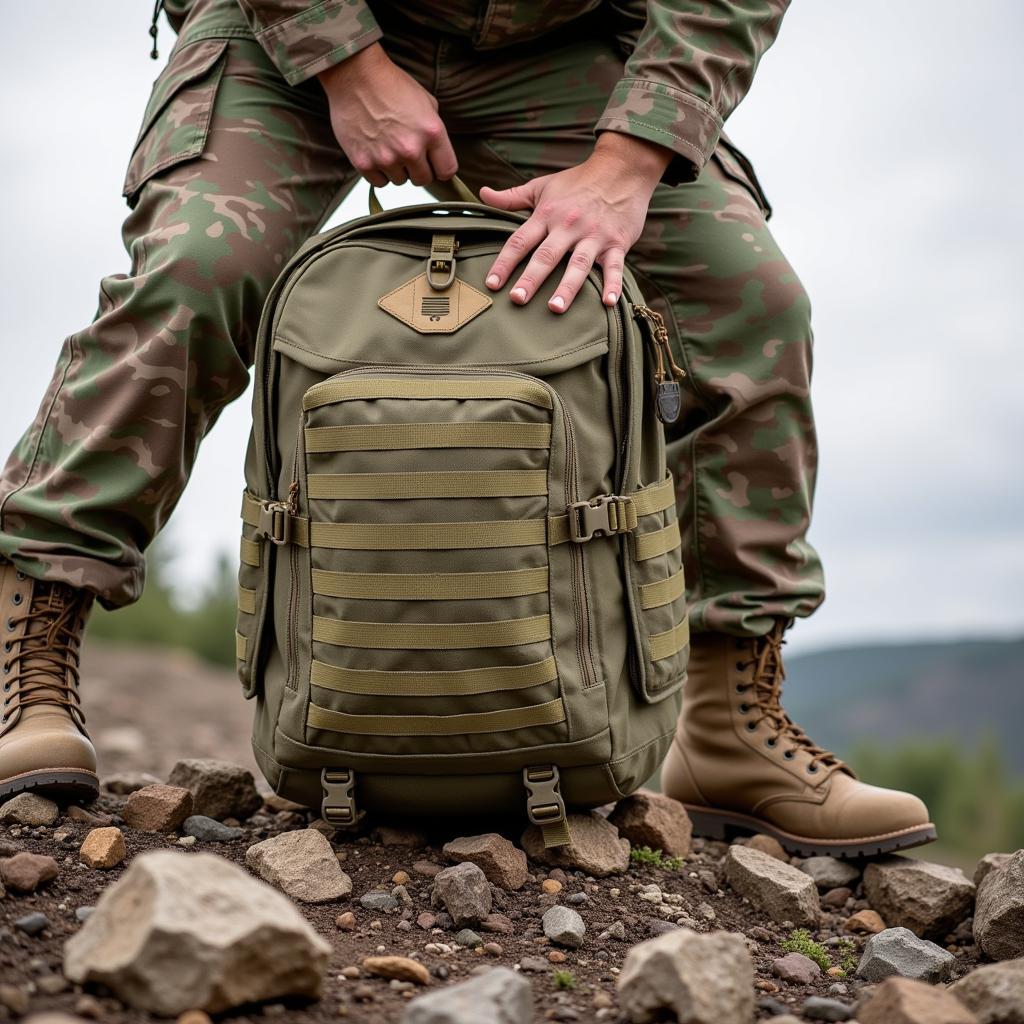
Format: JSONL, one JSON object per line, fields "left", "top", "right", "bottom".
{"left": 305, "top": 420, "right": 551, "bottom": 453}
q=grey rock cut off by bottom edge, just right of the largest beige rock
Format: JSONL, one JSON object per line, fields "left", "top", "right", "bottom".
{"left": 401, "top": 962, "right": 528, "bottom": 1024}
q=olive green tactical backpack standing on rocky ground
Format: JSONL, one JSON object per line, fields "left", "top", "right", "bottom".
{"left": 236, "top": 182, "right": 689, "bottom": 845}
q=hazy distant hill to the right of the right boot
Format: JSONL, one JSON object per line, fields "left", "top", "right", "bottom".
{"left": 784, "top": 638, "right": 1024, "bottom": 776}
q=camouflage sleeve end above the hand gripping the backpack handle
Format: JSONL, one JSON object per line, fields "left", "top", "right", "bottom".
{"left": 239, "top": 0, "right": 381, "bottom": 85}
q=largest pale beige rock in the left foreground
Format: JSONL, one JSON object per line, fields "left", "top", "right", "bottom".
{"left": 63, "top": 850, "right": 331, "bottom": 1017}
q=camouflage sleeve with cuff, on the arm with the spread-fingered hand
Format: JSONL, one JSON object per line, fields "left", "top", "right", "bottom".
{"left": 594, "top": 0, "right": 790, "bottom": 184}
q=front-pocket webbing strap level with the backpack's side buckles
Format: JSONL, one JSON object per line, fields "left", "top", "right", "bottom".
{"left": 307, "top": 519, "right": 547, "bottom": 551}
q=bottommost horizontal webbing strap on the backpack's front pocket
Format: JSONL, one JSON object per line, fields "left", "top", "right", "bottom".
{"left": 306, "top": 697, "right": 565, "bottom": 736}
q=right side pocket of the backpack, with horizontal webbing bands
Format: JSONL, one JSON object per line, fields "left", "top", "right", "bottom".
{"left": 627, "top": 475, "right": 690, "bottom": 702}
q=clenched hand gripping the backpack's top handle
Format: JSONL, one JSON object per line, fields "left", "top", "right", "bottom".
{"left": 316, "top": 43, "right": 459, "bottom": 187}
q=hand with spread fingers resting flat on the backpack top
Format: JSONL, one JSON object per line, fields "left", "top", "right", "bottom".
{"left": 480, "top": 131, "right": 672, "bottom": 313}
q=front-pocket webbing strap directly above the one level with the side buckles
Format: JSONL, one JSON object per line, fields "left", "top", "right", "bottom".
{"left": 309, "top": 469, "right": 548, "bottom": 501}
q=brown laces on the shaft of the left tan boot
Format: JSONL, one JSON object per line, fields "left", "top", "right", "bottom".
{"left": 3, "top": 583, "right": 88, "bottom": 726}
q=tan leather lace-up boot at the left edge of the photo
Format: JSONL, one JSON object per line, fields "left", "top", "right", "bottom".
{"left": 0, "top": 561, "right": 99, "bottom": 799}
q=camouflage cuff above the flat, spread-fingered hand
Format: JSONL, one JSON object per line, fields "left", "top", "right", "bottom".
{"left": 594, "top": 78, "right": 722, "bottom": 185}
